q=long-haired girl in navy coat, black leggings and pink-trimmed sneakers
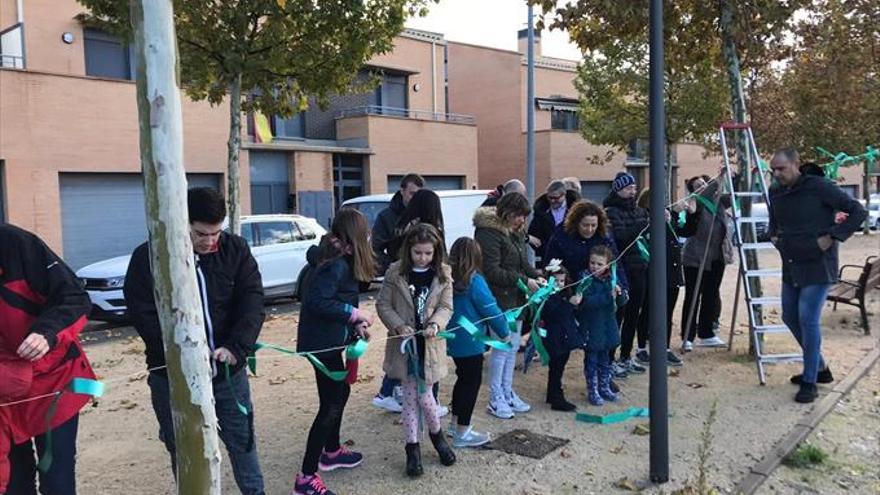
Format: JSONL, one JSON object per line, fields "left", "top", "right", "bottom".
{"left": 293, "top": 208, "right": 376, "bottom": 494}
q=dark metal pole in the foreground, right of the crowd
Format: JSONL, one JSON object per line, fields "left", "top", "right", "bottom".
{"left": 649, "top": 0, "right": 669, "bottom": 483}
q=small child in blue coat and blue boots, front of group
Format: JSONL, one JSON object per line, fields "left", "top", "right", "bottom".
{"left": 578, "top": 246, "right": 626, "bottom": 406}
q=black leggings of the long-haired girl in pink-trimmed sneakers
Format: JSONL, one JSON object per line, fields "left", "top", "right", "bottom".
{"left": 302, "top": 351, "right": 351, "bottom": 475}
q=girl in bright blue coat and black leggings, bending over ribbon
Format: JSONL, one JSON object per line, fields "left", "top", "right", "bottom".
{"left": 446, "top": 237, "right": 510, "bottom": 448}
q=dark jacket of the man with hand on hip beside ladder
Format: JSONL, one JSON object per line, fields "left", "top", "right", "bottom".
{"left": 769, "top": 175, "right": 868, "bottom": 287}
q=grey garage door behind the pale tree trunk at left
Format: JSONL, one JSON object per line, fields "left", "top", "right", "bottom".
{"left": 59, "top": 173, "right": 220, "bottom": 270}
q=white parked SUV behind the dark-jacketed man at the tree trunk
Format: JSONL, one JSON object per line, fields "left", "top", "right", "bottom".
{"left": 76, "top": 215, "right": 326, "bottom": 320}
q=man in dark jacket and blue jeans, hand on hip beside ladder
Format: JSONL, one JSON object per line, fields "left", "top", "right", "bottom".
{"left": 769, "top": 149, "right": 867, "bottom": 403}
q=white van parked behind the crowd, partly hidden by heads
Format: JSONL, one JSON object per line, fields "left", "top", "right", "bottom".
{"left": 342, "top": 189, "right": 490, "bottom": 252}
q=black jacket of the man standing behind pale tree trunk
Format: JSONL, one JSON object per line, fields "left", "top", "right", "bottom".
{"left": 123, "top": 232, "right": 265, "bottom": 379}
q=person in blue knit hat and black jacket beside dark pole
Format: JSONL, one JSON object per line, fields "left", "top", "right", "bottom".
{"left": 603, "top": 172, "right": 648, "bottom": 374}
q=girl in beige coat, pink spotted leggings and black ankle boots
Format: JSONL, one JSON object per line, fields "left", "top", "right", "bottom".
{"left": 376, "top": 224, "right": 455, "bottom": 477}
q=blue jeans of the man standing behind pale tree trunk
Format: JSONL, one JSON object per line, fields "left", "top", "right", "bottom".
{"left": 147, "top": 368, "right": 265, "bottom": 495}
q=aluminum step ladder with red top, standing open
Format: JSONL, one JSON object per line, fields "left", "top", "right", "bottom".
{"left": 719, "top": 123, "right": 803, "bottom": 385}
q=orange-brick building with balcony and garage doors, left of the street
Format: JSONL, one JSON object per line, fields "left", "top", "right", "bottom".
{"left": 0, "top": 0, "right": 477, "bottom": 268}
